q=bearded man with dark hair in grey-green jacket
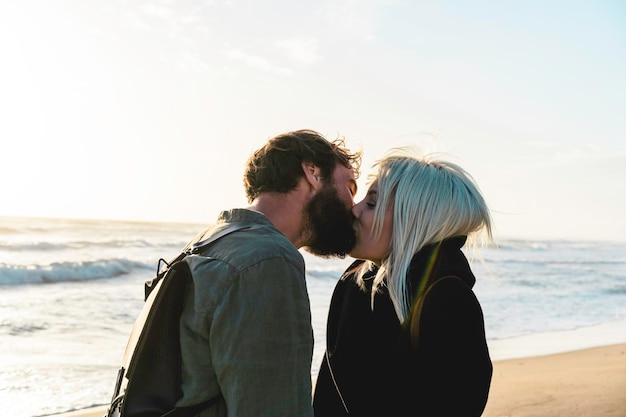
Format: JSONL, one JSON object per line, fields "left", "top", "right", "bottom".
{"left": 178, "top": 130, "right": 360, "bottom": 417}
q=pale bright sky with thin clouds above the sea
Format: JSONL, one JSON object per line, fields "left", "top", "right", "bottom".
{"left": 0, "top": 0, "right": 626, "bottom": 240}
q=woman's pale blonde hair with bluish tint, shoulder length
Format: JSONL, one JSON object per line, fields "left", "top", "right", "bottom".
{"left": 356, "top": 148, "right": 492, "bottom": 323}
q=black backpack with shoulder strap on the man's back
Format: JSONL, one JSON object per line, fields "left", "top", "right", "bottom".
{"left": 105, "top": 224, "right": 250, "bottom": 417}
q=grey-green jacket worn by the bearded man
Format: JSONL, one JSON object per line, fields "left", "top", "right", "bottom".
{"left": 178, "top": 209, "right": 313, "bottom": 417}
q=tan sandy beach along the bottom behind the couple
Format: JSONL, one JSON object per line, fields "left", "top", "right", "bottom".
{"left": 53, "top": 344, "right": 626, "bottom": 417}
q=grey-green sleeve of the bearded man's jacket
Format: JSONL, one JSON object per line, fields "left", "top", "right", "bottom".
{"left": 197, "top": 257, "right": 313, "bottom": 417}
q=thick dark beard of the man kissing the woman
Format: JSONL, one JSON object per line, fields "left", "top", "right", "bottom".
{"left": 304, "top": 185, "right": 356, "bottom": 258}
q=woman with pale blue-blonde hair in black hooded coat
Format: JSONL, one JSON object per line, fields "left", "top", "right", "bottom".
{"left": 313, "top": 149, "right": 492, "bottom": 417}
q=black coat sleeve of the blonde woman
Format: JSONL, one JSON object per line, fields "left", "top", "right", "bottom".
{"left": 413, "top": 279, "right": 493, "bottom": 417}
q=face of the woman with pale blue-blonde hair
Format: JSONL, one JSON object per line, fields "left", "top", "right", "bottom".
{"left": 350, "top": 180, "right": 393, "bottom": 265}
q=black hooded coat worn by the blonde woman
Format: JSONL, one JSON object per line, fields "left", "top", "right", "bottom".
{"left": 313, "top": 237, "right": 492, "bottom": 417}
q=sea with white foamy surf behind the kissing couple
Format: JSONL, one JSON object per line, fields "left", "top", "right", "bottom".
{"left": 0, "top": 217, "right": 626, "bottom": 417}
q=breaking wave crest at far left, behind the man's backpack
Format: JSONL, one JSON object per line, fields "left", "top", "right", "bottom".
{"left": 0, "top": 259, "right": 154, "bottom": 285}
